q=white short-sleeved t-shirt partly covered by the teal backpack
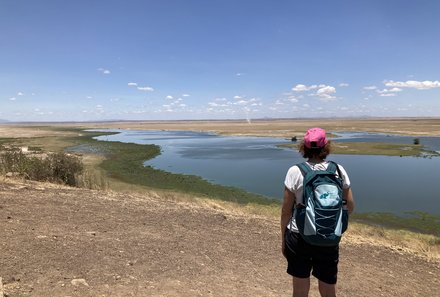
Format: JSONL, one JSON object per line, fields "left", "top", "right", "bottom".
{"left": 284, "top": 161, "right": 350, "bottom": 232}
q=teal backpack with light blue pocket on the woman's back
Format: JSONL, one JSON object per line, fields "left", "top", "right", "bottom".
{"left": 295, "top": 162, "right": 348, "bottom": 246}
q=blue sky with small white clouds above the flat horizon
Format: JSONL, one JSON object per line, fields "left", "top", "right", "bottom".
{"left": 0, "top": 0, "right": 440, "bottom": 121}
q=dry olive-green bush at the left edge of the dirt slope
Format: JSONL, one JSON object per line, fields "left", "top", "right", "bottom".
{"left": 0, "top": 148, "right": 84, "bottom": 186}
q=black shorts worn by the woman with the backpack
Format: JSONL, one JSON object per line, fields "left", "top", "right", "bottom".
{"left": 285, "top": 230, "right": 339, "bottom": 284}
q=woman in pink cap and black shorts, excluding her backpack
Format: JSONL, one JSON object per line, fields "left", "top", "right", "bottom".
{"left": 281, "top": 128, "right": 354, "bottom": 297}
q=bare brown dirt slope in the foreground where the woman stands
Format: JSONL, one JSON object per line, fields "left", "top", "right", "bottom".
{"left": 0, "top": 180, "right": 440, "bottom": 297}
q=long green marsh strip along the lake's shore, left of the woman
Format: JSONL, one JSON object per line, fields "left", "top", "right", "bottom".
{"left": 40, "top": 128, "right": 279, "bottom": 206}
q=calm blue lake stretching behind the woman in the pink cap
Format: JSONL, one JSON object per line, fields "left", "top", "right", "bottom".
{"left": 97, "top": 130, "right": 440, "bottom": 215}
